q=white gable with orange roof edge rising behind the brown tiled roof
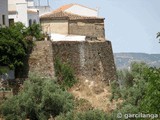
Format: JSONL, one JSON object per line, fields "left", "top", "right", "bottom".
{"left": 53, "top": 4, "right": 98, "bottom": 17}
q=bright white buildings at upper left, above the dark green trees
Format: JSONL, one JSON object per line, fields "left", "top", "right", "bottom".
{"left": 8, "top": 0, "right": 39, "bottom": 27}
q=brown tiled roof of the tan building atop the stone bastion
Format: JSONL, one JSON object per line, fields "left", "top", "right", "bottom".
{"left": 40, "top": 10, "right": 104, "bottom": 20}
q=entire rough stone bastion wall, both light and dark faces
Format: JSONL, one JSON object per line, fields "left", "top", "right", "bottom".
{"left": 29, "top": 41, "right": 116, "bottom": 83}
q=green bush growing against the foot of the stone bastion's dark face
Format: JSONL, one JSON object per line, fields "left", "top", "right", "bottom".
{"left": 54, "top": 59, "right": 77, "bottom": 88}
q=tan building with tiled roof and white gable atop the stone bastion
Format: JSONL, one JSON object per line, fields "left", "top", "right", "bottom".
{"left": 40, "top": 4, "right": 105, "bottom": 41}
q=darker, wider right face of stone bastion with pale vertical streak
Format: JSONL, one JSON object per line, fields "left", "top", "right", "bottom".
{"left": 52, "top": 41, "right": 116, "bottom": 83}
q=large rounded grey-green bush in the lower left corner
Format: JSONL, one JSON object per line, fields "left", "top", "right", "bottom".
{"left": 0, "top": 76, "right": 73, "bottom": 120}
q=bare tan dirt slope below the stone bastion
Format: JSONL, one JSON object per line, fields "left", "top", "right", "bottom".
{"left": 69, "top": 79, "right": 120, "bottom": 112}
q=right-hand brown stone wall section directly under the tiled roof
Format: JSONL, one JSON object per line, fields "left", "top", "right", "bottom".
{"left": 69, "top": 19, "right": 105, "bottom": 40}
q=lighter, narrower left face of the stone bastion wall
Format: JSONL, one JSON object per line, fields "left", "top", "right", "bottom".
{"left": 28, "top": 41, "right": 54, "bottom": 77}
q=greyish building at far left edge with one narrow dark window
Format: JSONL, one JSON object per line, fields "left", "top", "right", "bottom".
{"left": 0, "top": 0, "right": 8, "bottom": 26}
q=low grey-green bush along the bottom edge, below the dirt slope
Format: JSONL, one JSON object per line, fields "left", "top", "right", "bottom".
{"left": 56, "top": 110, "right": 109, "bottom": 120}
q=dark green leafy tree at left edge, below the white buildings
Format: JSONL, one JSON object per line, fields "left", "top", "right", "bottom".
{"left": 0, "top": 23, "right": 27, "bottom": 68}
